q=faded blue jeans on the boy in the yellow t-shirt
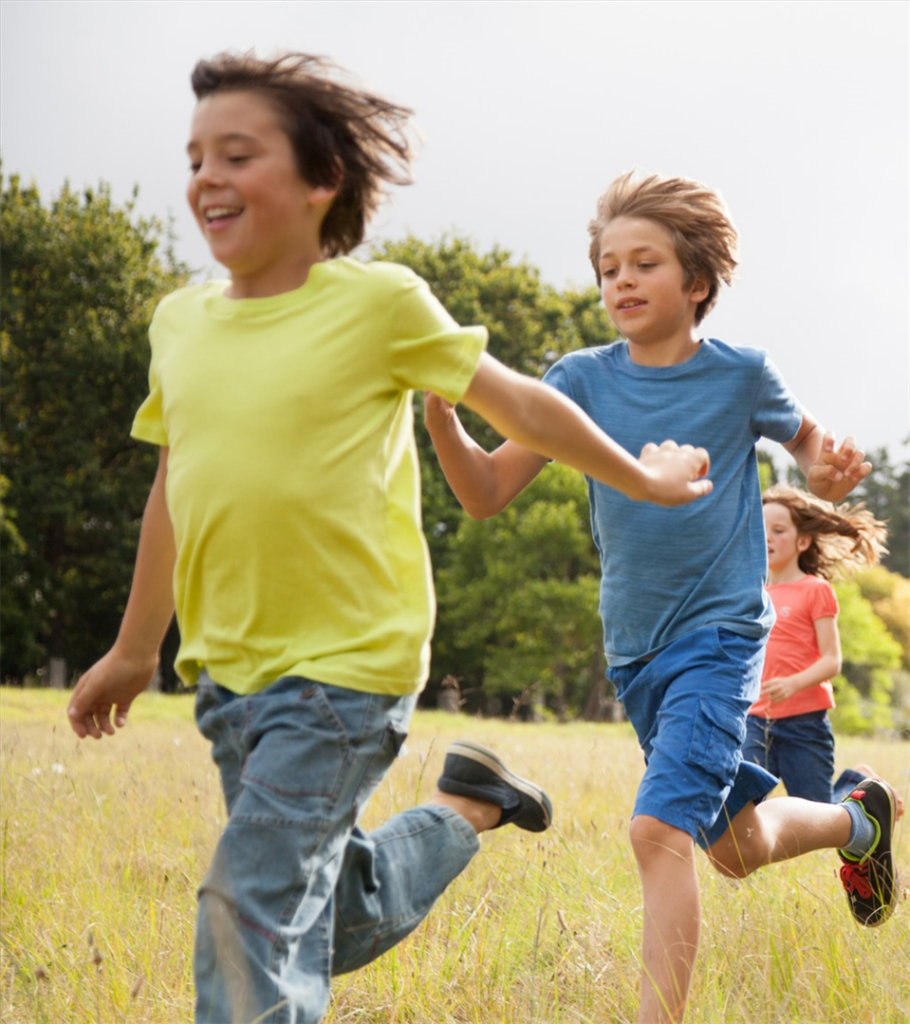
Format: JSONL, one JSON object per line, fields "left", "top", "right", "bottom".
{"left": 193, "top": 673, "right": 479, "bottom": 1024}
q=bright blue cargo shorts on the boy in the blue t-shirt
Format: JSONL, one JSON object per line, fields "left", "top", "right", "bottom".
{"left": 609, "top": 627, "right": 777, "bottom": 849}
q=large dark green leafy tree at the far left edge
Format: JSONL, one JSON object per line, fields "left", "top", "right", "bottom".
{"left": 0, "top": 176, "right": 186, "bottom": 680}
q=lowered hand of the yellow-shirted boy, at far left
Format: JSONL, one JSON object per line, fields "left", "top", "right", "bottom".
{"left": 67, "top": 648, "right": 157, "bottom": 739}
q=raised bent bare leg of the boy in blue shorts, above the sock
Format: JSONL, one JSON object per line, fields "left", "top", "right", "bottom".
{"left": 707, "top": 797, "right": 851, "bottom": 879}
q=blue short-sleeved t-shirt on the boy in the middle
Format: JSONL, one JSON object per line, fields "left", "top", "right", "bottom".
{"left": 545, "top": 340, "right": 803, "bottom": 666}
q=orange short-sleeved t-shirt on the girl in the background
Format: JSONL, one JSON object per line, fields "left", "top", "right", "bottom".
{"left": 749, "top": 575, "right": 837, "bottom": 718}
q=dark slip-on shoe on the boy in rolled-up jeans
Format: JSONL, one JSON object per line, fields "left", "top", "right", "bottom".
{"left": 436, "top": 740, "right": 553, "bottom": 831}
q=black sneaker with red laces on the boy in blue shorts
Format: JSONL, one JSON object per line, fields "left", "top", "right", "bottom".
{"left": 837, "top": 778, "right": 898, "bottom": 928}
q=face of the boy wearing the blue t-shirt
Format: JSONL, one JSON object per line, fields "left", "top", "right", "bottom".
{"left": 600, "top": 217, "right": 707, "bottom": 356}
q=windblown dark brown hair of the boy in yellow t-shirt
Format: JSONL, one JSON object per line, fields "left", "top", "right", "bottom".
{"left": 190, "top": 53, "right": 413, "bottom": 256}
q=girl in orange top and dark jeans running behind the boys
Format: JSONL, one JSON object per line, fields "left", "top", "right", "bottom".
{"left": 743, "top": 486, "right": 886, "bottom": 803}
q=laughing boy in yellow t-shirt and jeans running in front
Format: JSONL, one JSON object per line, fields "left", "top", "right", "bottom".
{"left": 69, "top": 54, "right": 711, "bottom": 1024}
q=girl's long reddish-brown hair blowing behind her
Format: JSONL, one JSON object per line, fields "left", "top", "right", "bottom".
{"left": 762, "top": 484, "right": 887, "bottom": 580}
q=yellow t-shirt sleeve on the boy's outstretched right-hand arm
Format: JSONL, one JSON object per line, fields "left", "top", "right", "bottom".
{"left": 389, "top": 270, "right": 487, "bottom": 402}
